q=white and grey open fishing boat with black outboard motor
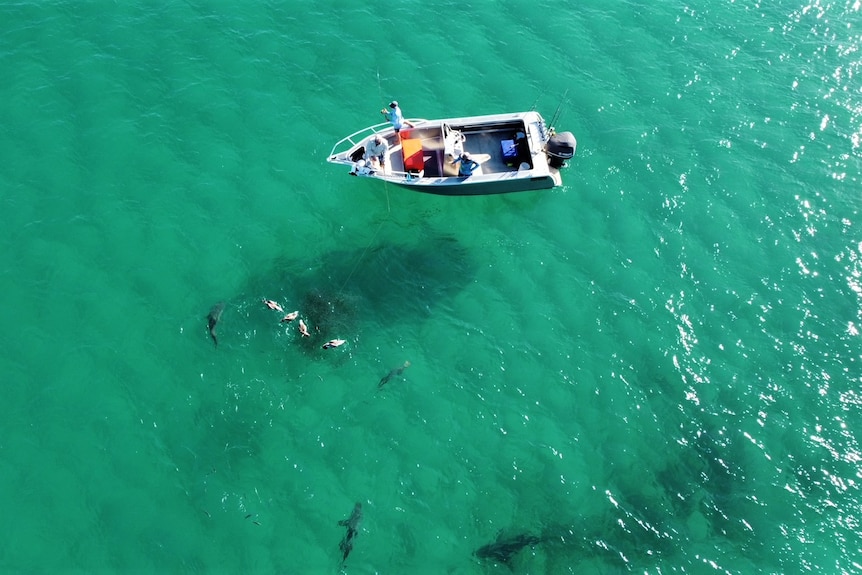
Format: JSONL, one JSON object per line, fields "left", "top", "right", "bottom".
{"left": 327, "top": 111, "right": 577, "bottom": 196}
